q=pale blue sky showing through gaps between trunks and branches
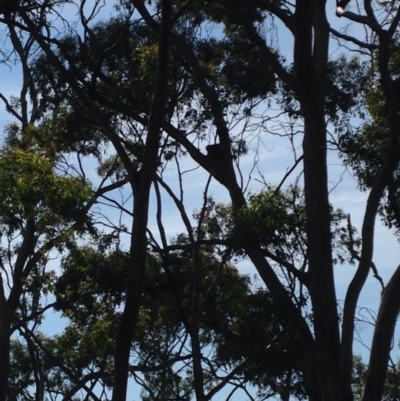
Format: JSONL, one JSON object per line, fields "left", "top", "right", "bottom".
{"left": 0, "top": 1, "right": 400, "bottom": 398}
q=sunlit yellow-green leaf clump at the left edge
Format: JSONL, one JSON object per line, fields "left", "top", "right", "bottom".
{"left": 0, "top": 128, "right": 92, "bottom": 235}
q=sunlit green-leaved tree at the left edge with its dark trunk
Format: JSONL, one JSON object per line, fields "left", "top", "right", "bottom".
{"left": 0, "top": 127, "right": 92, "bottom": 397}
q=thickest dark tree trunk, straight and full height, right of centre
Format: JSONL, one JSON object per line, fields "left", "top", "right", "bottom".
{"left": 294, "top": 0, "right": 341, "bottom": 401}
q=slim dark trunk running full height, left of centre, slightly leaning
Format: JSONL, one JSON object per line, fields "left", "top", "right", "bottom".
{"left": 112, "top": 0, "right": 171, "bottom": 401}
